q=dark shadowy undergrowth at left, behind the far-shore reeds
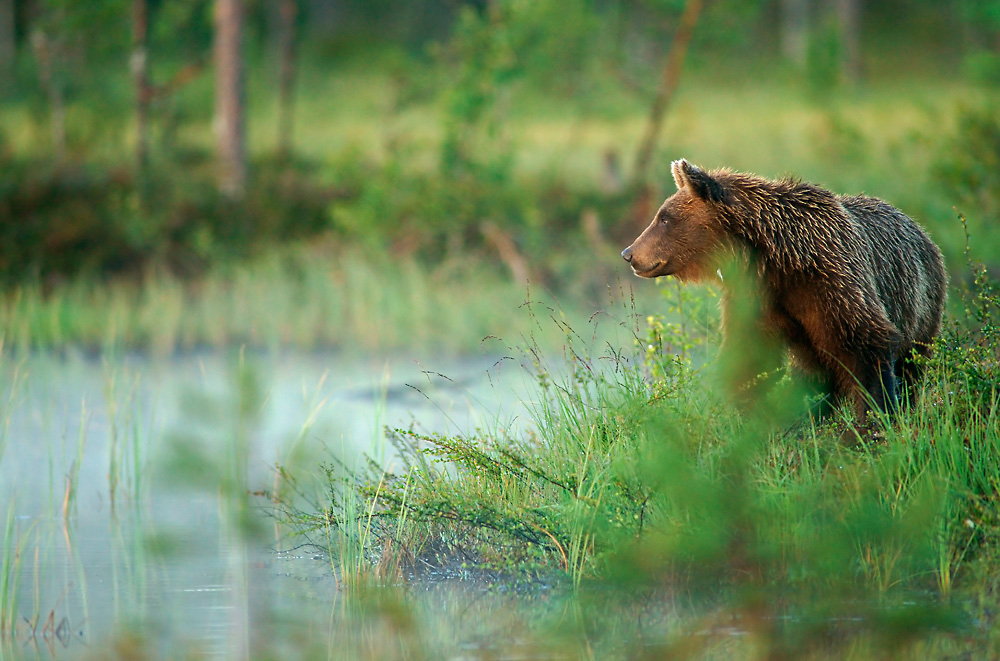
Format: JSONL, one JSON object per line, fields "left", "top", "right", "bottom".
{"left": 0, "top": 163, "right": 329, "bottom": 283}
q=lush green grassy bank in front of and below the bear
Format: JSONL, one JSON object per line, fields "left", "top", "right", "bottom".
{"left": 288, "top": 260, "right": 1000, "bottom": 658}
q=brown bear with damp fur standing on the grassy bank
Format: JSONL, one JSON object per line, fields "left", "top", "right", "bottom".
{"left": 622, "top": 160, "right": 947, "bottom": 421}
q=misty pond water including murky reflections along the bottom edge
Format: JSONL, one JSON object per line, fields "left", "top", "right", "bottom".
{"left": 0, "top": 353, "right": 978, "bottom": 661}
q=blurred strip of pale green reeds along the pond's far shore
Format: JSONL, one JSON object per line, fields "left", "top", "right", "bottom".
{"left": 0, "top": 249, "right": 624, "bottom": 356}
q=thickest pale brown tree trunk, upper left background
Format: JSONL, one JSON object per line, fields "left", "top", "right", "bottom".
{"left": 215, "top": 0, "right": 247, "bottom": 198}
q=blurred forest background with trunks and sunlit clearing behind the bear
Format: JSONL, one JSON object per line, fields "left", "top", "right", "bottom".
{"left": 0, "top": 0, "right": 1000, "bottom": 350}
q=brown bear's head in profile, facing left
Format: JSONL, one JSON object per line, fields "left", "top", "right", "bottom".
{"left": 622, "top": 159, "right": 727, "bottom": 281}
